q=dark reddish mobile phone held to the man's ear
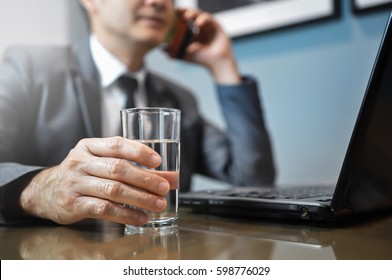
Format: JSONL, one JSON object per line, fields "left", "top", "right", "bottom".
{"left": 164, "top": 11, "right": 196, "bottom": 59}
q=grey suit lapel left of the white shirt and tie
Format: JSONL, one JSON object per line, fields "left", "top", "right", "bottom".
{"left": 72, "top": 40, "right": 101, "bottom": 137}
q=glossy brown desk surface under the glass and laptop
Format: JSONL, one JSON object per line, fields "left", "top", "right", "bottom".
{"left": 0, "top": 210, "right": 392, "bottom": 260}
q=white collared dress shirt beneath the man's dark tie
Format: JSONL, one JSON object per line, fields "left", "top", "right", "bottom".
{"left": 90, "top": 34, "right": 147, "bottom": 137}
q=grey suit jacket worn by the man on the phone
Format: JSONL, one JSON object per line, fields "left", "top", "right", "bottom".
{"left": 0, "top": 38, "right": 275, "bottom": 224}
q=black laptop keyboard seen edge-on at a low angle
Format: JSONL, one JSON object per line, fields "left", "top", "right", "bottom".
{"left": 220, "top": 187, "right": 334, "bottom": 199}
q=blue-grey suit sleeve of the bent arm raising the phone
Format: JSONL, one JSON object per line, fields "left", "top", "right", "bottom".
{"left": 202, "top": 77, "right": 275, "bottom": 186}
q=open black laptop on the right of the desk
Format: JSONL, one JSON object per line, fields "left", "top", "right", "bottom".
{"left": 180, "top": 13, "right": 392, "bottom": 222}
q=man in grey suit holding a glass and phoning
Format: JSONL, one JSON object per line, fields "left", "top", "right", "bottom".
{"left": 0, "top": 0, "right": 275, "bottom": 225}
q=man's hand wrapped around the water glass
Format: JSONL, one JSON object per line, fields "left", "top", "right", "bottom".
{"left": 20, "top": 137, "right": 170, "bottom": 225}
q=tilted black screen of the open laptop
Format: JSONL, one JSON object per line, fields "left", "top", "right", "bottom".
{"left": 332, "top": 14, "right": 392, "bottom": 212}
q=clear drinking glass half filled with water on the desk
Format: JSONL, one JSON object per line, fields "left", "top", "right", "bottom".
{"left": 121, "top": 107, "right": 181, "bottom": 234}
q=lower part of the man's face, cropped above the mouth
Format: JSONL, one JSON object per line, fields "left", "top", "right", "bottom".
{"left": 92, "top": 0, "right": 174, "bottom": 47}
